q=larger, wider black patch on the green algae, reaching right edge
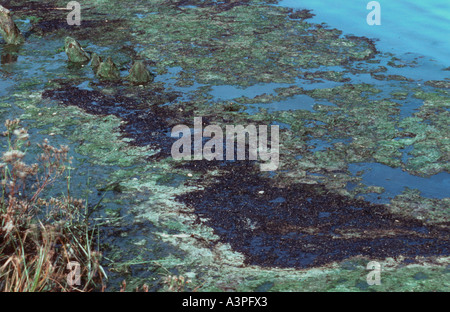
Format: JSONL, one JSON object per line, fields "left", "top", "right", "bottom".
{"left": 177, "top": 161, "right": 450, "bottom": 268}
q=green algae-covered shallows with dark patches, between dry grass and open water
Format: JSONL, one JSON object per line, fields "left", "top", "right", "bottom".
{"left": 0, "top": 0, "right": 450, "bottom": 292}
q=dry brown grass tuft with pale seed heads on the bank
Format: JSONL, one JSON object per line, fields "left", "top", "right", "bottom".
{"left": 0, "top": 120, "right": 106, "bottom": 292}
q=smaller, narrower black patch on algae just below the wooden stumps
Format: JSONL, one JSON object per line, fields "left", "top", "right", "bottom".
{"left": 42, "top": 86, "right": 180, "bottom": 157}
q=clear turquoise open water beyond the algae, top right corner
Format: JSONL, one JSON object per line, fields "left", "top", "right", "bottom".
{"left": 279, "top": 0, "right": 450, "bottom": 67}
